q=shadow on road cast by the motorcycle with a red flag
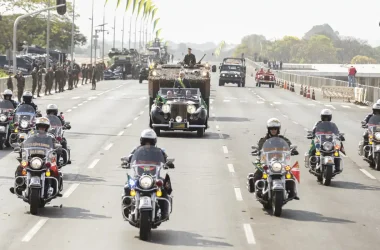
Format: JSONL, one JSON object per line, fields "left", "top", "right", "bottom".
{"left": 281, "top": 209, "right": 356, "bottom": 223}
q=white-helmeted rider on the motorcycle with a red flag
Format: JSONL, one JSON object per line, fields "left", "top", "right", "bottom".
{"left": 249, "top": 118, "right": 299, "bottom": 200}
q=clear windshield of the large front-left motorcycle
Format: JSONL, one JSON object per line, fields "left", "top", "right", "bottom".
{"left": 23, "top": 131, "right": 54, "bottom": 156}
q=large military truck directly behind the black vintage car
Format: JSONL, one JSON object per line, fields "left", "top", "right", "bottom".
{"left": 148, "top": 61, "right": 210, "bottom": 129}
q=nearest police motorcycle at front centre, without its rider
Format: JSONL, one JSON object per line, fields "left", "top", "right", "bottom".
{"left": 121, "top": 146, "right": 174, "bottom": 240}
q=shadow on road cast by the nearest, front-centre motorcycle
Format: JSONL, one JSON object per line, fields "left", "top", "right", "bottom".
{"left": 146, "top": 230, "right": 233, "bottom": 247}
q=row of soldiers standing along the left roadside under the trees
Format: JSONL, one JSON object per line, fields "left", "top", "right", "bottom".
{"left": 7, "top": 63, "right": 105, "bottom": 101}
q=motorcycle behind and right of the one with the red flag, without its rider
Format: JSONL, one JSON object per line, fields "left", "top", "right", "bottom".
{"left": 305, "top": 121, "right": 344, "bottom": 186}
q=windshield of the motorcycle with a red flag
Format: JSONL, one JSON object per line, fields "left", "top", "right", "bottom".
{"left": 261, "top": 137, "right": 290, "bottom": 165}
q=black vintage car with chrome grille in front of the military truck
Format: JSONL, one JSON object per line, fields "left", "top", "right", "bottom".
{"left": 150, "top": 88, "right": 208, "bottom": 137}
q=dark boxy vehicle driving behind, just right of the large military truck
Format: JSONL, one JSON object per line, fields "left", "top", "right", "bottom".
{"left": 219, "top": 58, "right": 246, "bottom": 87}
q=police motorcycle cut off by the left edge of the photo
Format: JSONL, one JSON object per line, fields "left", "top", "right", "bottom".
{"left": 0, "top": 100, "right": 14, "bottom": 150}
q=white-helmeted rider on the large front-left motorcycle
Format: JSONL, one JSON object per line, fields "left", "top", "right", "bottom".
{"left": 9, "top": 117, "right": 62, "bottom": 196}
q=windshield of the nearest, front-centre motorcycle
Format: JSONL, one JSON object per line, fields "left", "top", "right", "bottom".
{"left": 131, "top": 146, "right": 165, "bottom": 176}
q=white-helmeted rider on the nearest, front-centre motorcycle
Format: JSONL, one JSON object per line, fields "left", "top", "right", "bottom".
{"left": 122, "top": 129, "right": 174, "bottom": 219}
